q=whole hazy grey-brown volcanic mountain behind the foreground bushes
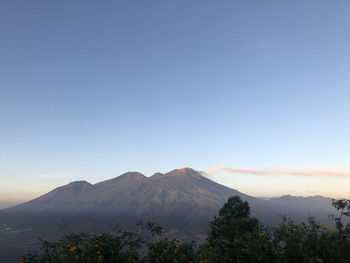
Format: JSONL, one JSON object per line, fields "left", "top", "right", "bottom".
{"left": 0, "top": 168, "right": 340, "bottom": 262}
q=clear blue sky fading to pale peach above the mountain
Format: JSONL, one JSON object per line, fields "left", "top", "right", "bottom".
{"left": 0, "top": 0, "right": 350, "bottom": 206}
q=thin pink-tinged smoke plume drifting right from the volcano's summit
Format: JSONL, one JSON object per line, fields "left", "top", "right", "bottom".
{"left": 203, "top": 166, "right": 350, "bottom": 177}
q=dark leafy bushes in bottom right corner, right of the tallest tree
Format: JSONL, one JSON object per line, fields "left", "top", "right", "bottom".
{"left": 271, "top": 217, "right": 350, "bottom": 263}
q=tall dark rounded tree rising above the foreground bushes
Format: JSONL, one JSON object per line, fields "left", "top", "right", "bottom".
{"left": 202, "top": 196, "right": 273, "bottom": 263}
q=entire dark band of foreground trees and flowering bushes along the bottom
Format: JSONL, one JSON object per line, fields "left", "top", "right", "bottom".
{"left": 22, "top": 196, "right": 350, "bottom": 263}
